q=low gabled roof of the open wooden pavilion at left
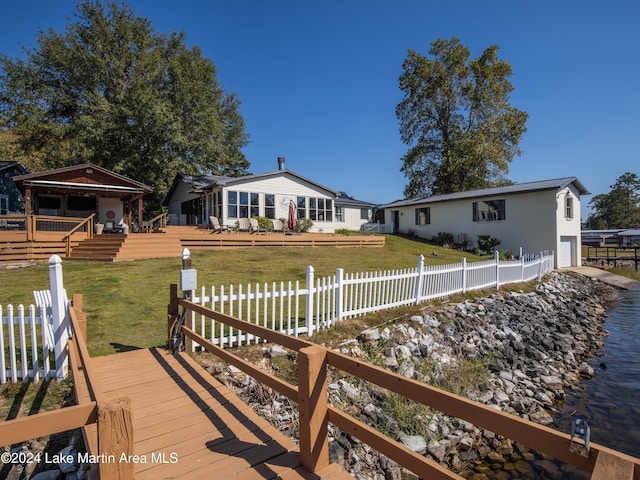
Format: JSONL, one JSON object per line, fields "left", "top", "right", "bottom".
{"left": 13, "top": 163, "right": 153, "bottom": 197}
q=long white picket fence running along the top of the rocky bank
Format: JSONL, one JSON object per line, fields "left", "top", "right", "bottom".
{"left": 187, "top": 248, "right": 554, "bottom": 347}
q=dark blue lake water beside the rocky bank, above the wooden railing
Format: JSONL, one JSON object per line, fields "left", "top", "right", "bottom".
{"left": 553, "top": 290, "right": 640, "bottom": 457}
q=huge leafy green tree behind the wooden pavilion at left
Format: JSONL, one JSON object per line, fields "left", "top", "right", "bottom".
{"left": 0, "top": 1, "right": 249, "bottom": 208}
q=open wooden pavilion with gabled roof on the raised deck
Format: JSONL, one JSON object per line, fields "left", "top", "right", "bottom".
{"left": 13, "top": 163, "right": 153, "bottom": 231}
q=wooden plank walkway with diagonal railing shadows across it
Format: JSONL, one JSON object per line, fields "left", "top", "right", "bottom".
{"left": 91, "top": 349, "right": 353, "bottom": 480}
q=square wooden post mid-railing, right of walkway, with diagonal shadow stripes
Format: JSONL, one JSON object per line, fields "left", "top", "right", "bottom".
{"left": 298, "top": 345, "right": 329, "bottom": 473}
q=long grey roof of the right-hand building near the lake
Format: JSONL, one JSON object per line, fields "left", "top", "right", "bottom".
{"left": 381, "top": 177, "right": 590, "bottom": 208}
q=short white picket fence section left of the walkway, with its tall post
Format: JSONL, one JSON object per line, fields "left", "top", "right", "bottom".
{"left": 0, "top": 255, "right": 69, "bottom": 384}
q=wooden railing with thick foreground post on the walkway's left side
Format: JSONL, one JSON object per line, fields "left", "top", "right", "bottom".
{"left": 0, "top": 295, "right": 133, "bottom": 480}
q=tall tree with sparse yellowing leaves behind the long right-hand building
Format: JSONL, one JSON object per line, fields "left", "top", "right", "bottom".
{"left": 396, "top": 38, "right": 528, "bottom": 197}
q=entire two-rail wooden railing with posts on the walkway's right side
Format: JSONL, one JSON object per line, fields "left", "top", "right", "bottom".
{"left": 168, "top": 285, "right": 640, "bottom": 480}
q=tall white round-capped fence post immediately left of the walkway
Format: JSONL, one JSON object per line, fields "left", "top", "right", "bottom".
{"left": 49, "top": 255, "right": 69, "bottom": 381}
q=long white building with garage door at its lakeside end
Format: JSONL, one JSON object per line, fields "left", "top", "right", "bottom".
{"left": 380, "top": 177, "right": 589, "bottom": 267}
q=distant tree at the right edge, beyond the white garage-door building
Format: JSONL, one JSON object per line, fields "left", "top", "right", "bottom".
{"left": 587, "top": 172, "right": 640, "bottom": 229}
